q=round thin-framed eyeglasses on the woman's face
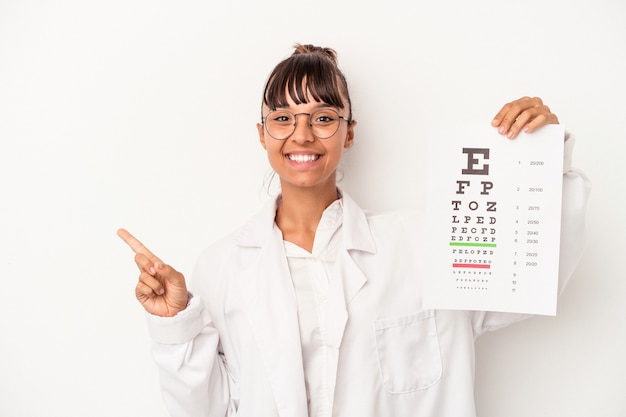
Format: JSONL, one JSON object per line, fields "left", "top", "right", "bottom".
{"left": 262, "top": 108, "right": 350, "bottom": 140}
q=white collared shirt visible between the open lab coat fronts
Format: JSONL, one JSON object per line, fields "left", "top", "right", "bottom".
{"left": 284, "top": 200, "right": 343, "bottom": 417}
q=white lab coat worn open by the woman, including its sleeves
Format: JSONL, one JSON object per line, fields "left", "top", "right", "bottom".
{"left": 148, "top": 135, "right": 589, "bottom": 417}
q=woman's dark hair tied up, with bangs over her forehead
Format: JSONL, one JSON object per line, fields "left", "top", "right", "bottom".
{"left": 263, "top": 44, "right": 352, "bottom": 122}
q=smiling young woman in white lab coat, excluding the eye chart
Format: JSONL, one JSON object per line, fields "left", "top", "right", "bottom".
{"left": 118, "top": 45, "right": 588, "bottom": 417}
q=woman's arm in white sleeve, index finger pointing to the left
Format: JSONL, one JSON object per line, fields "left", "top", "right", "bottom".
{"left": 117, "top": 229, "right": 236, "bottom": 417}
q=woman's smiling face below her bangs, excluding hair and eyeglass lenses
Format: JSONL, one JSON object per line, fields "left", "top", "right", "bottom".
{"left": 257, "top": 95, "right": 356, "bottom": 191}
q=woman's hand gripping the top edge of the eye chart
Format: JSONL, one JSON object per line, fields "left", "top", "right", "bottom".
{"left": 491, "top": 97, "right": 559, "bottom": 139}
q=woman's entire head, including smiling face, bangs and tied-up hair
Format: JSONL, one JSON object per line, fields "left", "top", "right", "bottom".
{"left": 257, "top": 45, "right": 356, "bottom": 195}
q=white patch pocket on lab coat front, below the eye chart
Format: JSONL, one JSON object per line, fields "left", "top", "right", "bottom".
{"left": 374, "top": 310, "right": 442, "bottom": 394}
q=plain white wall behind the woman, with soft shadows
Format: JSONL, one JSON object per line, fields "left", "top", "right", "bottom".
{"left": 0, "top": 0, "right": 626, "bottom": 417}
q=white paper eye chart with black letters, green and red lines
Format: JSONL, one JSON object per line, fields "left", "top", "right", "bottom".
{"left": 424, "top": 125, "right": 564, "bottom": 315}
